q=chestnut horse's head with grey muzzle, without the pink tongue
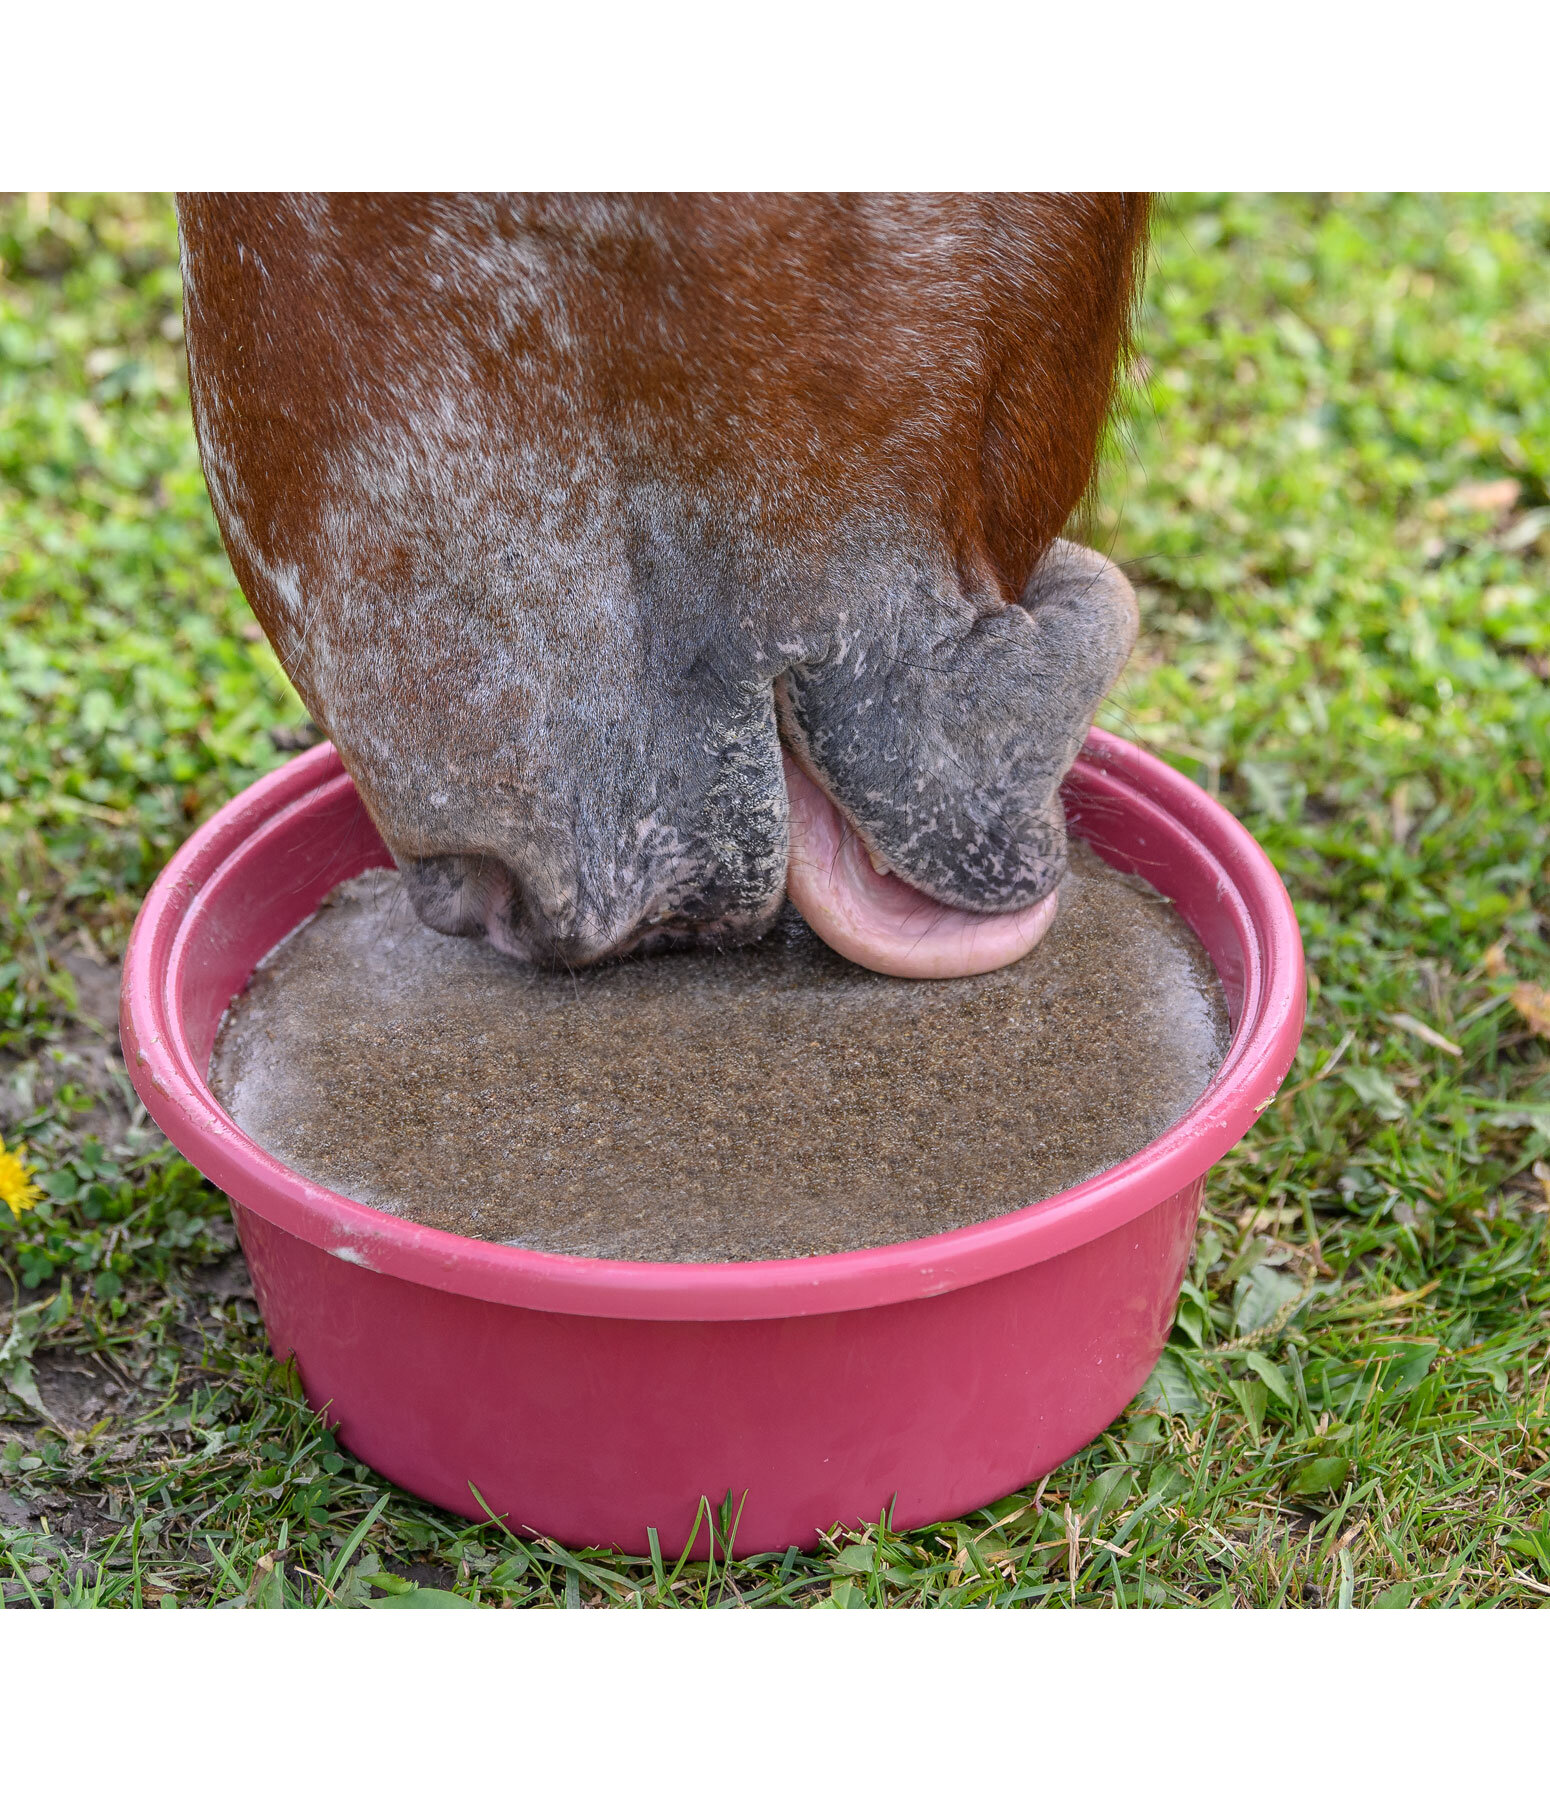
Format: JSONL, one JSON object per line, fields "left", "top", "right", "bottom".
{"left": 180, "top": 194, "right": 1147, "bottom": 961}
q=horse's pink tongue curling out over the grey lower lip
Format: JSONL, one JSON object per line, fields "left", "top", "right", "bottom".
{"left": 785, "top": 756, "right": 1057, "bottom": 979}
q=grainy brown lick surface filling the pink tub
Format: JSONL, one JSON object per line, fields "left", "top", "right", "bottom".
{"left": 211, "top": 842, "right": 1230, "bottom": 1262}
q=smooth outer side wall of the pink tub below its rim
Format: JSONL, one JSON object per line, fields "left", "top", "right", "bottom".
{"left": 236, "top": 1181, "right": 1203, "bottom": 1557}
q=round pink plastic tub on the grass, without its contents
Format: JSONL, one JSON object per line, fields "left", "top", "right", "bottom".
{"left": 121, "top": 731, "right": 1303, "bottom": 1555}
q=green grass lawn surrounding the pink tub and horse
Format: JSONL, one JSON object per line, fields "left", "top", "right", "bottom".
{"left": 0, "top": 196, "right": 1550, "bottom": 1606}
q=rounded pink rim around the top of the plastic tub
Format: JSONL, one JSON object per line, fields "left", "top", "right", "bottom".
{"left": 121, "top": 727, "right": 1305, "bottom": 1321}
